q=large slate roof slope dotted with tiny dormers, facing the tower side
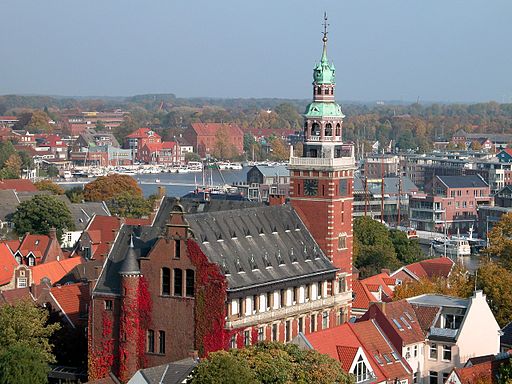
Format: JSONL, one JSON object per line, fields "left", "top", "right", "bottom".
{"left": 187, "top": 205, "right": 336, "bottom": 291}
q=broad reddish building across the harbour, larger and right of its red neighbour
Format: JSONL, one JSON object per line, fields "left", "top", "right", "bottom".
{"left": 183, "top": 123, "right": 244, "bottom": 157}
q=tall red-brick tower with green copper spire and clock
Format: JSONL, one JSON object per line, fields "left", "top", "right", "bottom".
{"left": 289, "top": 16, "right": 355, "bottom": 306}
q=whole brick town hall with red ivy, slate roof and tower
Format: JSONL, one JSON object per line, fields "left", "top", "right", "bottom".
{"left": 89, "top": 24, "right": 355, "bottom": 380}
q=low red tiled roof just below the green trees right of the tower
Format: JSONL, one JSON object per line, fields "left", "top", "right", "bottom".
{"left": 391, "top": 257, "right": 455, "bottom": 282}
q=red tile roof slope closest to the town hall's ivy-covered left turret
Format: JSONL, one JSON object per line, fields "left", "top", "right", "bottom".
{"left": 50, "top": 283, "right": 90, "bottom": 327}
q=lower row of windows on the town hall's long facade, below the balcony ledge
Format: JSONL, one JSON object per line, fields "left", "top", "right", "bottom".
{"left": 230, "top": 308, "right": 345, "bottom": 348}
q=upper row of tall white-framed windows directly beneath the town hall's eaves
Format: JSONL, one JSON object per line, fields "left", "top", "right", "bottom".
{"left": 228, "top": 277, "right": 347, "bottom": 316}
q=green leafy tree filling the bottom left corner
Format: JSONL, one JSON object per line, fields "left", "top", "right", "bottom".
{"left": 0, "top": 301, "right": 60, "bottom": 384}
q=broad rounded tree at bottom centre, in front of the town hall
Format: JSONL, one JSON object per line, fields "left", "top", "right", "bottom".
{"left": 188, "top": 342, "right": 353, "bottom": 384}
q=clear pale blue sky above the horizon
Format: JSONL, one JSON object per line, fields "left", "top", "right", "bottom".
{"left": 0, "top": 0, "right": 512, "bottom": 102}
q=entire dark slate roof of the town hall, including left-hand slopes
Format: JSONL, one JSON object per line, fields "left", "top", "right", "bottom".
{"left": 95, "top": 197, "right": 336, "bottom": 294}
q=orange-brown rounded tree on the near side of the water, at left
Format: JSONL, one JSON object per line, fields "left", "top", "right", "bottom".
{"left": 84, "top": 174, "right": 142, "bottom": 201}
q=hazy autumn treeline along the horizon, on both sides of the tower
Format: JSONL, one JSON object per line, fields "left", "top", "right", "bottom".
{"left": 0, "top": 94, "right": 512, "bottom": 152}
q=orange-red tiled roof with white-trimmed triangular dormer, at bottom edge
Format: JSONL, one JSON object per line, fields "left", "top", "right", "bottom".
{"left": 293, "top": 320, "right": 412, "bottom": 383}
